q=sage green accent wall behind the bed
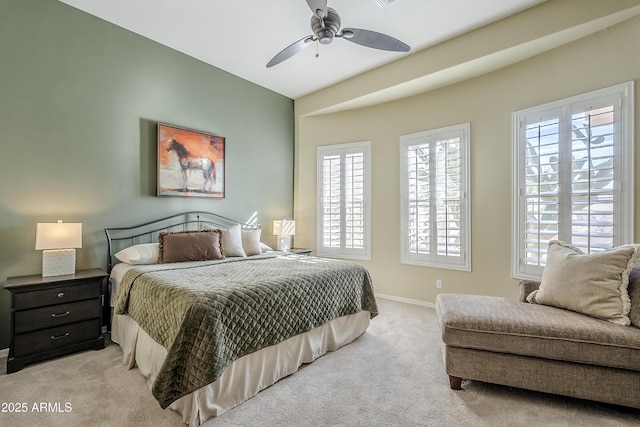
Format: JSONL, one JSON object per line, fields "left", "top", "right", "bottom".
{"left": 0, "top": 0, "right": 294, "bottom": 349}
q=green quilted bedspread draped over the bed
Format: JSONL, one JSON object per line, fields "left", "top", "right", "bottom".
{"left": 114, "top": 255, "right": 378, "bottom": 408}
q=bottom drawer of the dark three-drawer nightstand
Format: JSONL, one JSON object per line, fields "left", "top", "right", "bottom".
{"left": 13, "top": 319, "right": 100, "bottom": 357}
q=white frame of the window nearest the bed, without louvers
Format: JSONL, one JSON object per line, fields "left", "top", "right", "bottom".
{"left": 316, "top": 141, "right": 371, "bottom": 260}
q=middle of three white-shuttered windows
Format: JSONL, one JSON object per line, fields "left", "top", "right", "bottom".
{"left": 400, "top": 123, "right": 471, "bottom": 271}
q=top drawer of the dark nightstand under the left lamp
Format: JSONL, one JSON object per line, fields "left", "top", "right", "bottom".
{"left": 14, "top": 282, "right": 102, "bottom": 310}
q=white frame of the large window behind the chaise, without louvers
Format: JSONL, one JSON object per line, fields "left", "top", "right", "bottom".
{"left": 511, "top": 81, "right": 634, "bottom": 280}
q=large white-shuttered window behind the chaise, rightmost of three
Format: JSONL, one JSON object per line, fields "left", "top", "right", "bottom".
{"left": 512, "top": 82, "right": 634, "bottom": 279}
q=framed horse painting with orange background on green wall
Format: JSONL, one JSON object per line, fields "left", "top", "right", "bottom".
{"left": 158, "top": 123, "right": 225, "bottom": 199}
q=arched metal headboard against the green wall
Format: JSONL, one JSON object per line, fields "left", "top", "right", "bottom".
{"left": 104, "top": 211, "right": 260, "bottom": 273}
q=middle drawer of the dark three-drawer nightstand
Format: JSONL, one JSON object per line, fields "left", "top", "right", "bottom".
{"left": 15, "top": 298, "right": 102, "bottom": 334}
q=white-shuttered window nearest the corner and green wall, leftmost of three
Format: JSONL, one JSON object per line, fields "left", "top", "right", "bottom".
{"left": 317, "top": 142, "right": 371, "bottom": 259}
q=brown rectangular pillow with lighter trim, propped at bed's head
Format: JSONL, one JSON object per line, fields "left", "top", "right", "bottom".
{"left": 158, "top": 230, "right": 224, "bottom": 263}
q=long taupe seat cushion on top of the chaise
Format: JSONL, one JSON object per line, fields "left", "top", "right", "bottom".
{"left": 436, "top": 294, "right": 640, "bottom": 371}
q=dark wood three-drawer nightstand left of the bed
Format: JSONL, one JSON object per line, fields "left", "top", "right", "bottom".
{"left": 4, "top": 268, "right": 107, "bottom": 374}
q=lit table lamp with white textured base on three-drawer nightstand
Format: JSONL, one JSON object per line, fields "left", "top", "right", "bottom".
{"left": 36, "top": 220, "right": 82, "bottom": 277}
